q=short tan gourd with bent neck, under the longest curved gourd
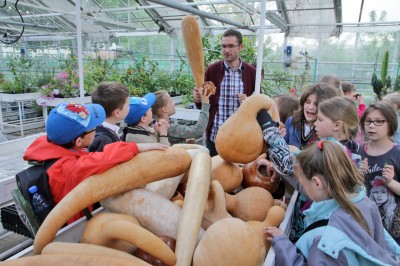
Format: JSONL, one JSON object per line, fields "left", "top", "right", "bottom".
{"left": 81, "top": 213, "right": 176, "bottom": 265}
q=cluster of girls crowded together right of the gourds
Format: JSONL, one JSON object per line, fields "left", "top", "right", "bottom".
{"left": 260, "top": 75, "right": 400, "bottom": 265}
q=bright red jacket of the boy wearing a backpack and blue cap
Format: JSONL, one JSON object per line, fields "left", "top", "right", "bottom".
{"left": 24, "top": 136, "right": 139, "bottom": 223}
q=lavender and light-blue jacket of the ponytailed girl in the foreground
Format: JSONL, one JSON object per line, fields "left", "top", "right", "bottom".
{"left": 272, "top": 187, "right": 400, "bottom": 266}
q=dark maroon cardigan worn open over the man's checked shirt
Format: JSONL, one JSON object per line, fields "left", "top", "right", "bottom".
{"left": 196, "top": 60, "right": 256, "bottom": 139}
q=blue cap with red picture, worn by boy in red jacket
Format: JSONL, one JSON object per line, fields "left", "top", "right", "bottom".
{"left": 46, "top": 102, "right": 106, "bottom": 145}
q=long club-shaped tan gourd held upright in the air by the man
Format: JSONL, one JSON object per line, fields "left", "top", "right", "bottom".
{"left": 181, "top": 15, "right": 204, "bottom": 88}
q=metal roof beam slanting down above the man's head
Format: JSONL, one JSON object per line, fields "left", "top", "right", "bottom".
{"left": 149, "top": 0, "right": 256, "bottom": 32}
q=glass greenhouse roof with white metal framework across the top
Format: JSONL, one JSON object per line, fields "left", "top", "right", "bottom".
{"left": 0, "top": 0, "right": 400, "bottom": 43}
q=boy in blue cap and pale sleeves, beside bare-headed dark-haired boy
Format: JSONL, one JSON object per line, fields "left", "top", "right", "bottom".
{"left": 122, "top": 93, "right": 171, "bottom": 146}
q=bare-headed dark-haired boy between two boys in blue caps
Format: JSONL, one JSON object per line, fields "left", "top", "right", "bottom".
{"left": 89, "top": 82, "right": 129, "bottom": 151}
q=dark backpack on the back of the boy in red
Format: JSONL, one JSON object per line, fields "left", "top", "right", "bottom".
{"left": 12, "top": 159, "right": 58, "bottom": 235}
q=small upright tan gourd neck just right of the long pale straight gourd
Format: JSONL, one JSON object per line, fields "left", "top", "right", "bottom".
{"left": 201, "top": 180, "right": 232, "bottom": 230}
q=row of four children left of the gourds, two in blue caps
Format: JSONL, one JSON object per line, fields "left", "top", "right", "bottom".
{"left": 24, "top": 82, "right": 210, "bottom": 223}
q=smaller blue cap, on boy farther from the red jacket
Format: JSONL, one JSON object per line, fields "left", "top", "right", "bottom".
{"left": 125, "top": 93, "right": 156, "bottom": 125}
